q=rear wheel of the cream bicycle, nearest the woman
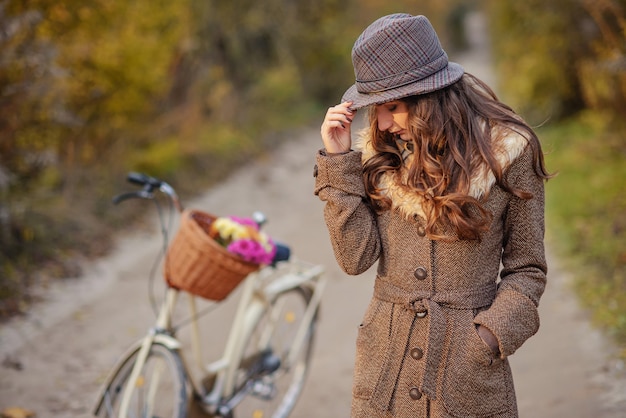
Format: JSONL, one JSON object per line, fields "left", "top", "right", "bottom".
{"left": 229, "top": 287, "right": 318, "bottom": 418}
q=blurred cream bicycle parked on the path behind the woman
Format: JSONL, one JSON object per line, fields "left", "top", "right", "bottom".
{"left": 93, "top": 173, "right": 325, "bottom": 418}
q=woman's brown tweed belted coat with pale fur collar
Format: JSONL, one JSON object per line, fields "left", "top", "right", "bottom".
{"left": 315, "top": 128, "right": 547, "bottom": 418}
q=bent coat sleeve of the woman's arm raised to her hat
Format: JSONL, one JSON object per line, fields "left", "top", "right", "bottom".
{"left": 315, "top": 151, "right": 381, "bottom": 275}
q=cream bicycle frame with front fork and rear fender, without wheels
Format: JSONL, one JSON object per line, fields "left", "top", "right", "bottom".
{"left": 114, "top": 260, "right": 326, "bottom": 418}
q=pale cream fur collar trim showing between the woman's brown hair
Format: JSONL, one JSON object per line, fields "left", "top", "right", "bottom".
{"left": 354, "top": 127, "right": 528, "bottom": 219}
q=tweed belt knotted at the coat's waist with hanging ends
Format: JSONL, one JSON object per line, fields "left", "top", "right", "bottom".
{"left": 373, "top": 277, "right": 496, "bottom": 410}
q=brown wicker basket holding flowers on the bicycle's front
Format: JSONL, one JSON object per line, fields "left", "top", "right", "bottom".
{"left": 164, "top": 210, "right": 259, "bottom": 301}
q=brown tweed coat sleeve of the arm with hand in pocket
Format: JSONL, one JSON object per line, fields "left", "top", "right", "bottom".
{"left": 474, "top": 147, "right": 547, "bottom": 358}
